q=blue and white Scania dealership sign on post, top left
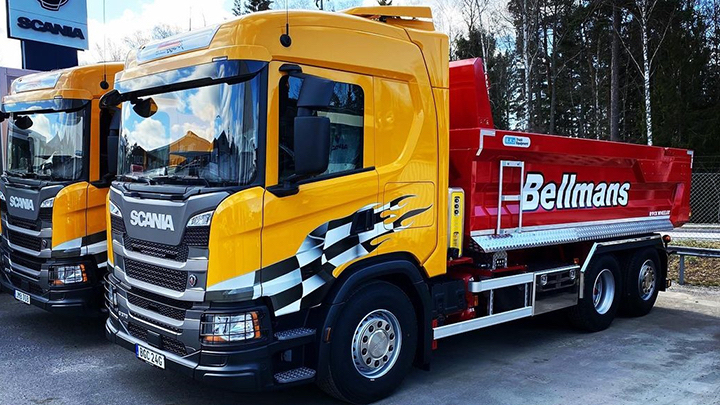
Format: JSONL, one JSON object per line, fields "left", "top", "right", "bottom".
{"left": 7, "top": 0, "right": 88, "bottom": 49}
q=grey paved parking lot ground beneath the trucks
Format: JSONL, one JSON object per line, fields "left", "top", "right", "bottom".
{"left": 0, "top": 288, "right": 720, "bottom": 405}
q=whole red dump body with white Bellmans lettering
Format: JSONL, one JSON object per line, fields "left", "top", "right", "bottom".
{"left": 450, "top": 59, "right": 692, "bottom": 251}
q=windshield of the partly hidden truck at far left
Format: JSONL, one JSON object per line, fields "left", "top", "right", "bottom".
{"left": 7, "top": 108, "right": 89, "bottom": 181}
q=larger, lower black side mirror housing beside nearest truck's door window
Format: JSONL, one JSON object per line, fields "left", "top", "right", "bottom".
{"left": 294, "top": 116, "right": 330, "bottom": 178}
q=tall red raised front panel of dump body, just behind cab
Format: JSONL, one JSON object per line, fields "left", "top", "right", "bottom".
{"left": 450, "top": 59, "right": 494, "bottom": 129}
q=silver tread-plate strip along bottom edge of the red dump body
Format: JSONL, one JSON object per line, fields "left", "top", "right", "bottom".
{"left": 472, "top": 218, "right": 673, "bottom": 253}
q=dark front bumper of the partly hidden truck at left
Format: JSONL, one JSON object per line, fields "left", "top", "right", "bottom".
{"left": 0, "top": 249, "right": 104, "bottom": 317}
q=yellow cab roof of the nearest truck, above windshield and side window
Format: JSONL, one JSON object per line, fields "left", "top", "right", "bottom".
{"left": 116, "top": 6, "right": 449, "bottom": 88}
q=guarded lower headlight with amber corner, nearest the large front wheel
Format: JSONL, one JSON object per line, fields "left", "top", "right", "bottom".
{"left": 200, "top": 311, "right": 261, "bottom": 344}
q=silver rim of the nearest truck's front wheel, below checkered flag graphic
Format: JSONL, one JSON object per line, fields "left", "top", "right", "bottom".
{"left": 351, "top": 309, "right": 402, "bottom": 379}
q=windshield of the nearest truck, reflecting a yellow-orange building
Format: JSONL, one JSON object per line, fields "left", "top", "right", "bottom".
{"left": 119, "top": 77, "right": 260, "bottom": 186}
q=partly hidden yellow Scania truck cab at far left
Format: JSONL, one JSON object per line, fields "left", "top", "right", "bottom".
{"left": 0, "top": 63, "right": 123, "bottom": 315}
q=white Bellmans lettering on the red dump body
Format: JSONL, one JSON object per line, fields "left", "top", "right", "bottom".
{"left": 522, "top": 173, "right": 630, "bottom": 211}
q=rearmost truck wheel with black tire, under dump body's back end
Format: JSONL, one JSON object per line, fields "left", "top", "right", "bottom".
{"left": 621, "top": 248, "right": 661, "bottom": 316}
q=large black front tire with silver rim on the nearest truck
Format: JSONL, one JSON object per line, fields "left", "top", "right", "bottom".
{"left": 318, "top": 281, "right": 417, "bottom": 404}
